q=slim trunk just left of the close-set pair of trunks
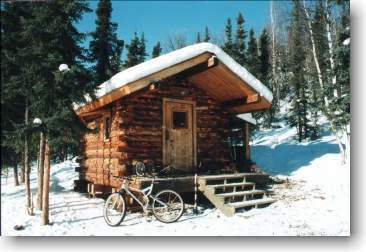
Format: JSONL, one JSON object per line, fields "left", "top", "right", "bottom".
{"left": 24, "top": 99, "right": 33, "bottom": 215}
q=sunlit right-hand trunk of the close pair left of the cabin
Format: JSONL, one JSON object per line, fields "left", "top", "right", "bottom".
{"left": 41, "top": 137, "right": 50, "bottom": 225}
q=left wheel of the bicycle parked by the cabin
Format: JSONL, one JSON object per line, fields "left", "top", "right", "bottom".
{"left": 103, "top": 193, "right": 127, "bottom": 226}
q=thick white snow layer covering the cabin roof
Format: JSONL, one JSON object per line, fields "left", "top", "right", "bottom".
{"left": 74, "top": 43, "right": 273, "bottom": 109}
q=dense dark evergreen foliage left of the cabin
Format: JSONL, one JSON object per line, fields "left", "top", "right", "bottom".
{"left": 2, "top": 1, "right": 95, "bottom": 165}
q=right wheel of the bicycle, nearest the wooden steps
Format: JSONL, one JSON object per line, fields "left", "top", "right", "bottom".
{"left": 153, "top": 190, "right": 184, "bottom": 223}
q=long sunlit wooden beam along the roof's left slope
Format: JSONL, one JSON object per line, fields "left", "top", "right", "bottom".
{"left": 76, "top": 53, "right": 212, "bottom": 115}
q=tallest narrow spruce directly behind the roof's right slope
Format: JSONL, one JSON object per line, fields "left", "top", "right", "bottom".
{"left": 234, "top": 12, "right": 247, "bottom": 66}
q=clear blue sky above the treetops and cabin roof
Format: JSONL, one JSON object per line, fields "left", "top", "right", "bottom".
{"left": 77, "top": 1, "right": 269, "bottom": 58}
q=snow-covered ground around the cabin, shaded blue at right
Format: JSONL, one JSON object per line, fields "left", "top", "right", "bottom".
{"left": 1, "top": 122, "right": 350, "bottom": 236}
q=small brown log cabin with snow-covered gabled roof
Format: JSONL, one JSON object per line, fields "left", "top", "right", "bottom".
{"left": 75, "top": 43, "right": 273, "bottom": 215}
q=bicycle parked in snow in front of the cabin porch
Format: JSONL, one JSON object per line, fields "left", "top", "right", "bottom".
{"left": 103, "top": 175, "right": 184, "bottom": 226}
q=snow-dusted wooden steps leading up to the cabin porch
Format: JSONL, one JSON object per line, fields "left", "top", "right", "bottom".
{"left": 198, "top": 173, "right": 275, "bottom": 216}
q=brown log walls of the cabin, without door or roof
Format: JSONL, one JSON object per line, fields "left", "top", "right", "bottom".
{"left": 82, "top": 78, "right": 243, "bottom": 186}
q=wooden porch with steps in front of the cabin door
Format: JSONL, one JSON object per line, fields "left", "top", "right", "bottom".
{"left": 84, "top": 172, "right": 275, "bottom": 216}
